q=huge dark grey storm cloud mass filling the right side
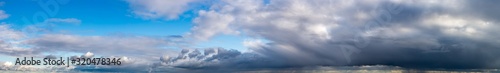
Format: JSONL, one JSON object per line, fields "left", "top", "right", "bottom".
{"left": 185, "top": 0, "right": 500, "bottom": 68}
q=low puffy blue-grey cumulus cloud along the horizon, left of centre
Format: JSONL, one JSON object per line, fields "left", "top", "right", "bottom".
{"left": 151, "top": 48, "right": 283, "bottom": 72}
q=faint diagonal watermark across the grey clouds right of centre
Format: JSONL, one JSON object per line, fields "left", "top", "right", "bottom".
{"left": 340, "top": 2, "right": 403, "bottom": 63}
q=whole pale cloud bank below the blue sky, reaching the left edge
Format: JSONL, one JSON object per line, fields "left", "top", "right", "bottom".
{"left": 0, "top": 23, "right": 182, "bottom": 72}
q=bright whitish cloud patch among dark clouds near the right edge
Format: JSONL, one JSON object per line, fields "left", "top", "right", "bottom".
{"left": 422, "top": 15, "right": 492, "bottom": 39}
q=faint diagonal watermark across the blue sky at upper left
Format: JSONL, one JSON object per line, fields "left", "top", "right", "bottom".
{"left": 21, "top": 0, "right": 70, "bottom": 31}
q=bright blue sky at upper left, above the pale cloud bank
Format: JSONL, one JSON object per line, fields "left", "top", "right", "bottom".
{"left": 2, "top": 0, "right": 195, "bottom": 36}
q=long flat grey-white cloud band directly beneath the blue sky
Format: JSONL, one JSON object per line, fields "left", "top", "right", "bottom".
{"left": 24, "top": 34, "right": 181, "bottom": 58}
